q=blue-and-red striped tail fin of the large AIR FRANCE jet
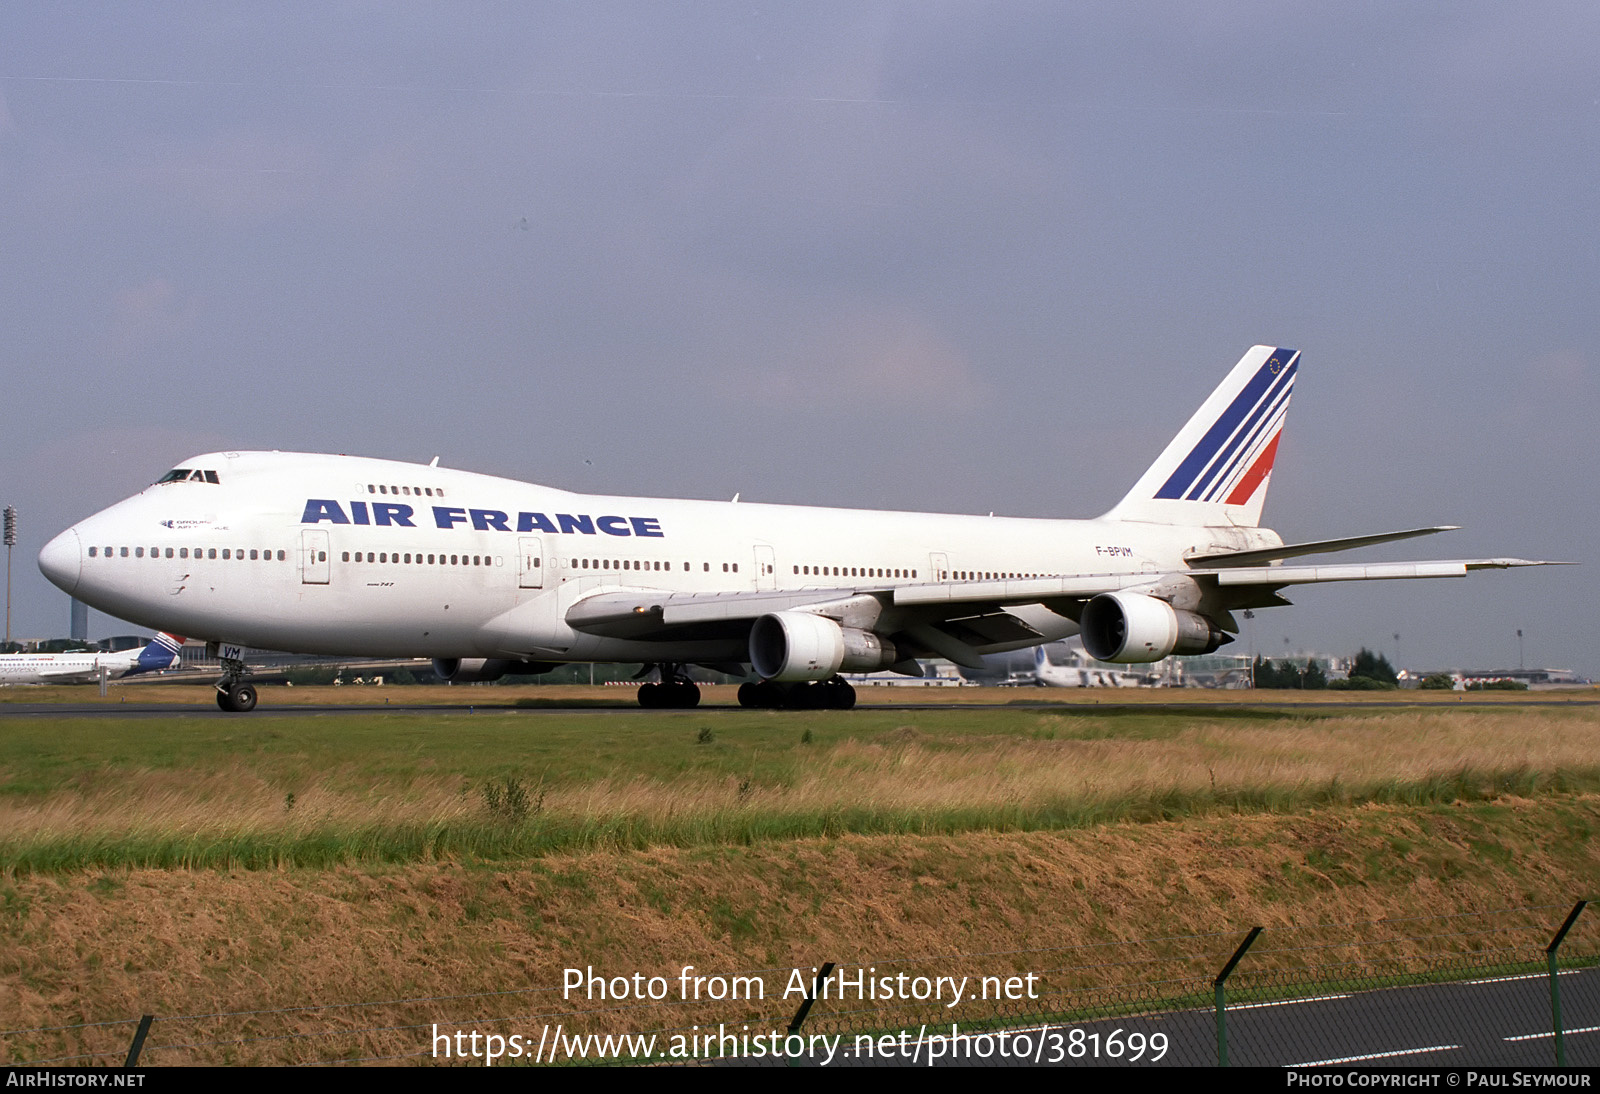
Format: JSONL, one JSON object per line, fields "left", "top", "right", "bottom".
{"left": 1106, "top": 345, "right": 1299, "bottom": 528}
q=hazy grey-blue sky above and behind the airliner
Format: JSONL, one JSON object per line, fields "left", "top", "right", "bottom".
{"left": 0, "top": 0, "right": 1600, "bottom": 673}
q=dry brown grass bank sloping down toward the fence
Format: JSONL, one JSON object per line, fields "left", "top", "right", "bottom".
{"left": 0, "top": 795, "right": 1600, "bottom": 1064}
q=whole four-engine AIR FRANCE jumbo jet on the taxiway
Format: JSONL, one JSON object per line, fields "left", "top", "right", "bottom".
{"left": 38, "top": 345, "right": 1561, "bottom": 710}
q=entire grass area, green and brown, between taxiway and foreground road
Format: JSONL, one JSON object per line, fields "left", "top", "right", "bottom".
{"left": 0, "top": 685, "right": 1600, "bottom": 1062}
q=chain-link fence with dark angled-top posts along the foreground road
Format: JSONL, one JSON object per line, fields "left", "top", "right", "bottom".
{"left": 0, "top": 904, "right": 1600, "bottom": 1067}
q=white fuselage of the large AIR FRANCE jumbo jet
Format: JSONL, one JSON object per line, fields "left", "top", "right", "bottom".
{"left": 40, "top": 453, "right": 1280, "bottom": 661}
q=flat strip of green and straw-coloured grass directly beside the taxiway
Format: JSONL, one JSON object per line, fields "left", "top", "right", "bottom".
{"left": 0, "top": 707, "right": 1600, "bottom": 878}
